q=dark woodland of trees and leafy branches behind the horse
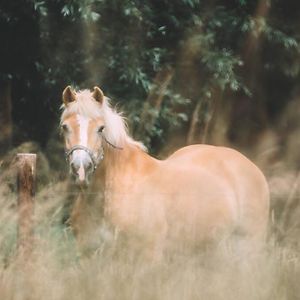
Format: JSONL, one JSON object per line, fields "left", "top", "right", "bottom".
{"left": 0, "top": 0, "right": 300, "bottom": 159}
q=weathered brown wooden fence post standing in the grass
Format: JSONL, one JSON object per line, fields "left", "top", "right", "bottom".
{"left": 17, "top": 153, "right": 36, "bottom": 255}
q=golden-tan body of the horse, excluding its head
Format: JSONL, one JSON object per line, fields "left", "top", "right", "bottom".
{"left": 60, "top": 86, "right": 269, "bottom": 255}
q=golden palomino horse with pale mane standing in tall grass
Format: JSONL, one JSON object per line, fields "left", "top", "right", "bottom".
{"left": 61, "top": 87, "right": 269, "bottom": 253}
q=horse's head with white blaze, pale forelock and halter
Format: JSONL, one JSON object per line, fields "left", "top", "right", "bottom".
{"left": 60, "top": 86, "right": 105, "bottom": 186}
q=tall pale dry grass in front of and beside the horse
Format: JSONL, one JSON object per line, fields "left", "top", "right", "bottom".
{"left": 0, "top": 141, "right": 300, "bottom": 300}
